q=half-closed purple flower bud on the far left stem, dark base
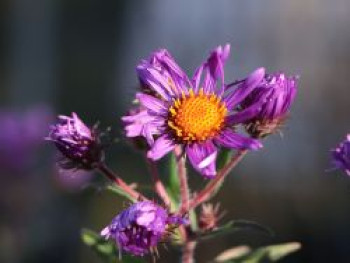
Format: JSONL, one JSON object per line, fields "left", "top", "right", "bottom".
{"left": 47, "top": 113, "right": 103, "bottom": 170}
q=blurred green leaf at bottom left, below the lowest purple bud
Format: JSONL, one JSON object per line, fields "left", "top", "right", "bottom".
{"left": 81, "top": 229, "right": 144, "bottom": 263}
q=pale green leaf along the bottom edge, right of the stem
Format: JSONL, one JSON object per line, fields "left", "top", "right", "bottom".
{"left": 214, "top": 242, "right": 301, "bottom": 263}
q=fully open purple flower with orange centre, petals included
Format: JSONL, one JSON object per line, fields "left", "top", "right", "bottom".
{"left": 124, "top": 45, "right": 265, "bottom": 178}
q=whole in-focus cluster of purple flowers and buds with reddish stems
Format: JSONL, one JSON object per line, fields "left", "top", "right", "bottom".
{"left": 48, "top": 45, "right": 297, "bottom": 256}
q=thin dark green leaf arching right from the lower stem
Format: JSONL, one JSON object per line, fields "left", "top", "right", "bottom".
{"left": 197, "top": 220, "right": 273, "bottom": 243}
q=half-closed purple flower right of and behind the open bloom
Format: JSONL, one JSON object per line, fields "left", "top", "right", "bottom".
{"left": 240, "top": 73, "right": 297, "bottom": 138}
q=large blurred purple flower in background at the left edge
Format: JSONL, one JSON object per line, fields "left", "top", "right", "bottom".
{"left": 0, "top": 106, "right": 51, "bottom": 173}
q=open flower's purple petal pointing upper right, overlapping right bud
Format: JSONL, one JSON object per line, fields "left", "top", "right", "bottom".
{"left": 225, "top": 68, "right": 265, "bottom": 109}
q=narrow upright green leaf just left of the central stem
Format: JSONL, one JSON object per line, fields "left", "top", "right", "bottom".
{"left": 166, "top": 153, "right": 180, "bottom": 210}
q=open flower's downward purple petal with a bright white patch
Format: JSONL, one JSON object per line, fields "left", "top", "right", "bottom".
{"left": 186, "top": 141, "right": 217, "bottom": 178}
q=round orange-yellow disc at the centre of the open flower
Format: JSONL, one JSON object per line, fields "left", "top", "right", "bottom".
{"left": 168, "top": 89, "right": 227, "bottom": 142}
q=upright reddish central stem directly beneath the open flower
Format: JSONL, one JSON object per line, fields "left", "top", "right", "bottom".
{"left": 174, "top": 146, "right": 190, "bottom": 216}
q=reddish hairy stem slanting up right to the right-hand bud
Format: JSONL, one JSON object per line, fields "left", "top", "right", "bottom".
{"left": 187, "top": 150, "right": 248, "bottom": 212}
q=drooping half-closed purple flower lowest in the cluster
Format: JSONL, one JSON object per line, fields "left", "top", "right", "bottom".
{"left": 101, "top": 201, "right": 182, "bottom": 256}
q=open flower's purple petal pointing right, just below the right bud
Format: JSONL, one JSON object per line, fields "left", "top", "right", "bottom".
{"left": 215, "top": 129, "right": 262, "bottom": 150}
